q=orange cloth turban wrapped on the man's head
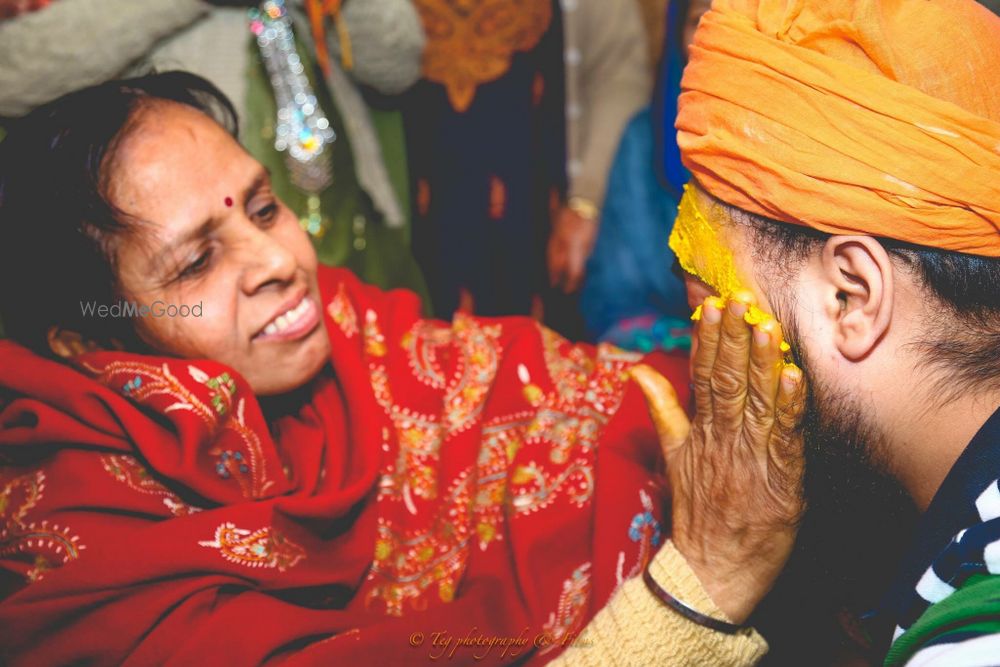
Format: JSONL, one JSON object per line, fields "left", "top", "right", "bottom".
{"left": 677, "top": 0, "right": 1000, "bottom": 257}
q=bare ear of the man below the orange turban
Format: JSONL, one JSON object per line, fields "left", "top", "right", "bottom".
{"left": 821, "top": 236, "right": 895, "bottom": 361}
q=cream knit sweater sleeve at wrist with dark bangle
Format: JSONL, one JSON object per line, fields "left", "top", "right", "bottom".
{"left": 549, "top": 541, "right": 767, "bottom": 667}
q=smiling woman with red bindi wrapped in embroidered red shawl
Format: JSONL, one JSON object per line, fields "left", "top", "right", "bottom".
{"left": 0, "top": 73, "right": 704, "bottom": 664}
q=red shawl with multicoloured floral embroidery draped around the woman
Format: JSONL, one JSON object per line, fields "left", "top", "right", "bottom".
{"left": 0, "top": 270, "right": 686, "bottom": 665}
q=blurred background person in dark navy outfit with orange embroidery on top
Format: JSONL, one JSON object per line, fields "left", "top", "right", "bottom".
{"left": 402, "top": 0, "right": 566, "bottom": 332}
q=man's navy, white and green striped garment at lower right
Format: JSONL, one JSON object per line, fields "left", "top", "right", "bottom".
{"left": 881, "top": 410, "right": 1000, "bottom": 667}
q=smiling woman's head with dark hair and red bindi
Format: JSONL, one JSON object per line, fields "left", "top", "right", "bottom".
{"left": 4, "top": 79, "right": 329, "bottom": 395}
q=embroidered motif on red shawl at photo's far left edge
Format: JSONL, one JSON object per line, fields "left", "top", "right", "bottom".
{"left": 0, "top": 470, "right": 86, "bottom": 582}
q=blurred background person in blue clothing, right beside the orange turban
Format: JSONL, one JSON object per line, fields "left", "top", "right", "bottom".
{"left": 581, "top": 0, "right": 711, "bottom": 351}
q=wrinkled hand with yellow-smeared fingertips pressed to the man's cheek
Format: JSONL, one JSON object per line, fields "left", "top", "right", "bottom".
{"left": 633, "top": 294, "right": 805, "bottom": 623}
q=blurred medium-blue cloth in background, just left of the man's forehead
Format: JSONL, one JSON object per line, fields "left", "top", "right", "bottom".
{"left": 581, "top": 108, "right": 690, "bottom": 339}
